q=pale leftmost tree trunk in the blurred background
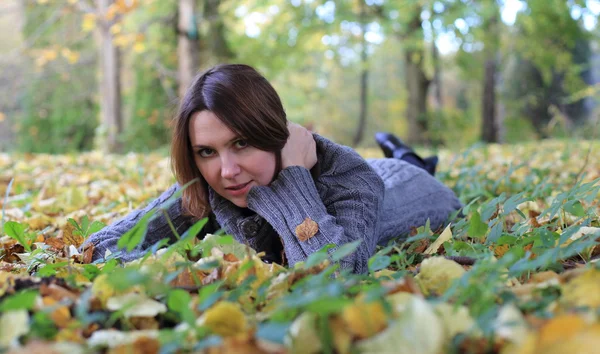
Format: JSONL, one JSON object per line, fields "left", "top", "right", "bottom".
{"left": 97, "top": 0, "right": 123, "bottom": 153}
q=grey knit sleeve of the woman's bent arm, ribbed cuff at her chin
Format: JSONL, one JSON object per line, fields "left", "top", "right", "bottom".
{"left": 248, "top": 164, "right": 383, "bottom": 273}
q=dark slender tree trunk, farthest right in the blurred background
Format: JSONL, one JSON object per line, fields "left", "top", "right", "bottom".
{"left": 481, "top": 0, "right": 500, "bottom": 143}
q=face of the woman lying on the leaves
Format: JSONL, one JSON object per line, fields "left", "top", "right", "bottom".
{"left": 190, "top": 111, "right": 275, "bottom": 208}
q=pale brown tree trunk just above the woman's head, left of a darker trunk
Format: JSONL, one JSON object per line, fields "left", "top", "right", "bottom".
{"left": 177, "top": 0, "right": 199, "bottom": 98}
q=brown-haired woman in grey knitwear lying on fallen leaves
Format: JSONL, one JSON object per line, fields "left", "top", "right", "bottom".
{"left": 88, "top": 65, "right": 461, "bottom": 273}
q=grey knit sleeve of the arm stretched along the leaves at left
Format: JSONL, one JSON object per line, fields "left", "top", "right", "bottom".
{"left": 83, "top": 184, "right": 190, "bottom": 262}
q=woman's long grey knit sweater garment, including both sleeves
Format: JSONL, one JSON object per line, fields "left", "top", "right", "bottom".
{"left": 87, "top": 134, "right": 462, "bottom": 273}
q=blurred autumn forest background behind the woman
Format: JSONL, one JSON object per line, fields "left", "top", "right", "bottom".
{"left": 0, "top": 0, "right": 600, "bottom": 153}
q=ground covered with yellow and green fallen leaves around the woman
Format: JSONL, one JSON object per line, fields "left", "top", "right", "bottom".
{"left": 0, "top": 141, "right": 600, "bottom": 354}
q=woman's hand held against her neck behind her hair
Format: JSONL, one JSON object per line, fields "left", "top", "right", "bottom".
{"left": 281, "top": 122, "right": 317, "bottom": 170}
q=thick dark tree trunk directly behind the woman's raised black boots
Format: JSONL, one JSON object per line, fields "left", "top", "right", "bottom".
{"left": 404, "top": 7, "right": 431, "bottom": 144}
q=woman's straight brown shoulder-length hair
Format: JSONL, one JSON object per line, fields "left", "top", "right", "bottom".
{"left": 171, "top": 64, "right": 289, "bottom": 218}
